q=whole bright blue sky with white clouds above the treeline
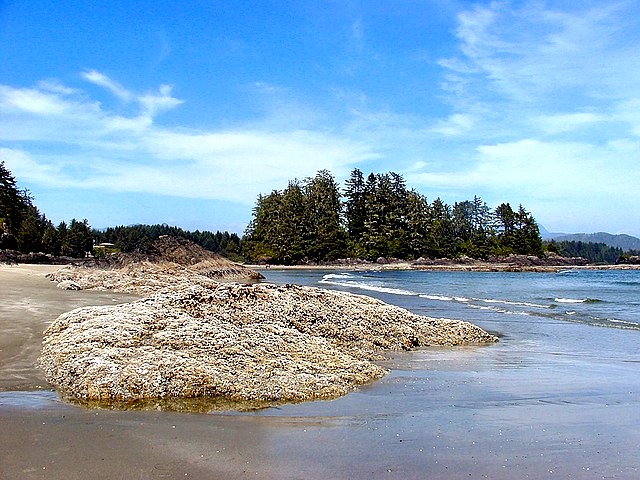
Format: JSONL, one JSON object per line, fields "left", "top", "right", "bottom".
{"left": 0, "top": 0, "right": 640, "bottom": 235}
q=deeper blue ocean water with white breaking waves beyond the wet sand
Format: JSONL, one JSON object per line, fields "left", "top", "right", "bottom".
{"left": 267, "top": 270, "right": 640, "bottom": 330}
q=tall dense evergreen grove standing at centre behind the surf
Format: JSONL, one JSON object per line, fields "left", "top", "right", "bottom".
{"left": 242, "top": 169, "right": 543, "bottom": 264}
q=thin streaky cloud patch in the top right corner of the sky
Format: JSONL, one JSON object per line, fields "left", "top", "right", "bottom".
{"left": 439, "top": 2, "right": 640, "bottom": 122}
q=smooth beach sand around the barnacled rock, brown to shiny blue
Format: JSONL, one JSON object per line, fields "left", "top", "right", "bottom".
{"left": 0, "top": 266, "right": 640, "bottom": 479}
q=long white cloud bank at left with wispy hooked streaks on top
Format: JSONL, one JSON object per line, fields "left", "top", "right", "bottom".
{"left": 0, "top": 72, "right": 375, "bottom": 204}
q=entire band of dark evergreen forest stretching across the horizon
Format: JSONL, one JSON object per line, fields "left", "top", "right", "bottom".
{"left": 0, "top": 162, "right": 639, "bottom": 264}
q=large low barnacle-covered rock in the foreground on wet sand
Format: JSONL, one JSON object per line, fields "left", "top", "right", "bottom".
{"left": 40, "top": 276, "right": 497, "bottom": 402}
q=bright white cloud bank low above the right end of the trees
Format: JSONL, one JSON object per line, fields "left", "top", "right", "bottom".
{"left": 407, "top": 139, "right": 640, "bottom": 232}
